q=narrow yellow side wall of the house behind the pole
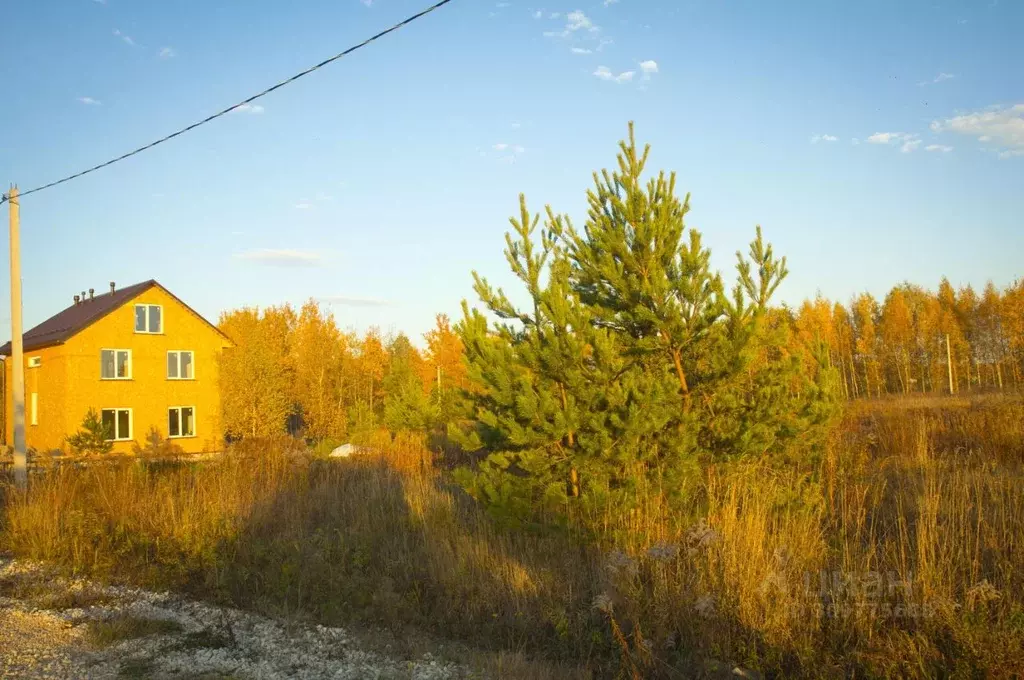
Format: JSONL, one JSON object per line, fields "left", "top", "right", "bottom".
{"left": 4, "top": 345, "right": 68, "bottom": 451}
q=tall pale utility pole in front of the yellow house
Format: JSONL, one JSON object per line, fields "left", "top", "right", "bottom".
{"left": 7, "top": 186, "right": 29, "bottom": 492}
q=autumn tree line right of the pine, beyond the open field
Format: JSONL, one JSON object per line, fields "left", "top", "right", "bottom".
{"left": 796, "top": 278, "right": 1024, "bottom": 398}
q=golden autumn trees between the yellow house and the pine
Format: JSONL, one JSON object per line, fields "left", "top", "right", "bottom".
{"left": 218, "top": 300, "right": 469, "bottom": 441}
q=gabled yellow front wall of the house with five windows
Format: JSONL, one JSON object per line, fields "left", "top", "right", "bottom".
{"left": 63, "top": 287, "right": 227, "bottom": 453}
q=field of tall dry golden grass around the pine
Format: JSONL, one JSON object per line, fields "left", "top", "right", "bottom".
{"left": 0, "top": 396, "right": 1024, "bottom": 678}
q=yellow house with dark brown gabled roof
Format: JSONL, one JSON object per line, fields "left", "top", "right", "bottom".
{"left": 0, "top": 281, "right": 230, "bottom": 453}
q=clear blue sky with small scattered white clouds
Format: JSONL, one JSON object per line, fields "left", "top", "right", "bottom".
{"left": 0, "top": 0, "right": 1024, "bottom": 340}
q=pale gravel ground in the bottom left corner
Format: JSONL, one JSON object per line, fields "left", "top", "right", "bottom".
{"left": 0, "top": 558, "right": 470, "bottom": 680}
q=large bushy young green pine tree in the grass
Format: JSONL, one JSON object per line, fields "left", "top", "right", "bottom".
{"left": 457, "top": 126, "right": 837, "bottom": 518}
